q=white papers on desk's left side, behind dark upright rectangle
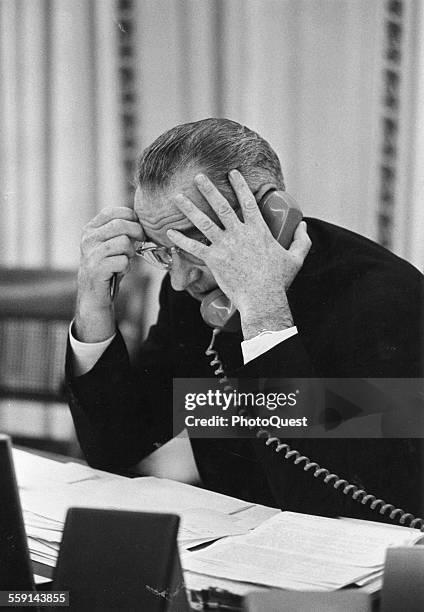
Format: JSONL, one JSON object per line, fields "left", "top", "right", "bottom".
{"left": 13, "top": 450, "right": 279, "bottom": 566}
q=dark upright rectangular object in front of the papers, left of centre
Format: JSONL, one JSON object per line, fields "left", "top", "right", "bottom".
{"left": 52, "top": 508, "right": 189, "bottom": 612}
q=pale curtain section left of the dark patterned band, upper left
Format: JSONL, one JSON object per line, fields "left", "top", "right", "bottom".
{"left": 0, "top": 0, "right": 123, "bottom": 268}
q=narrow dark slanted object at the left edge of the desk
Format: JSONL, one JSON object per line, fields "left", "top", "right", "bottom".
{"left": 0, "top": 434, "right": 35, "bottom": 591}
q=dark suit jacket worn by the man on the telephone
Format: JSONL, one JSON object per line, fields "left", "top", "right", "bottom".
{"left": 67, "top": 219, "right": 423, "bottom": 520}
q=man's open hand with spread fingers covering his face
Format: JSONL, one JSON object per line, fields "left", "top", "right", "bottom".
{"left": 167, "top": 170, "right": 311, "bottom": 337}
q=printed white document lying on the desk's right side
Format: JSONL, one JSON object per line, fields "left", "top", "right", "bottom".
{"left": 182, "top": 512, "right": 422, "bottom": 590}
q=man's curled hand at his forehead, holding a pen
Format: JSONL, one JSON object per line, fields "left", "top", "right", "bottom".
{"left": 74, "top": 206, "right": 145, "bottom": 342}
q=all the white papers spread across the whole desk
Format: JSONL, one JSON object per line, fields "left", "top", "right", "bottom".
{"left": 13, "top": 450, "right": 422, "bottom": 590}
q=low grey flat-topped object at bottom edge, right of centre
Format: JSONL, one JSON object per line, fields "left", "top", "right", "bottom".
{"left": 244, "top": 590, "right": 371, "bottom": 612}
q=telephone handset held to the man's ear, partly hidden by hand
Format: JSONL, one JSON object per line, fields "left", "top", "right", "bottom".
{"left": 200, "top": 191, "right": 303, "bottom": 332}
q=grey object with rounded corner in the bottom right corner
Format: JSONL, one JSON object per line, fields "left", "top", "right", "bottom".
{"left": 381, "top": 544, "right": 424, "bottom": 612}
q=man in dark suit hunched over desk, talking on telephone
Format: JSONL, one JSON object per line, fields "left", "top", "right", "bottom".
{"left": 67, "top": 119, "right": 422, "bottom": 519}
